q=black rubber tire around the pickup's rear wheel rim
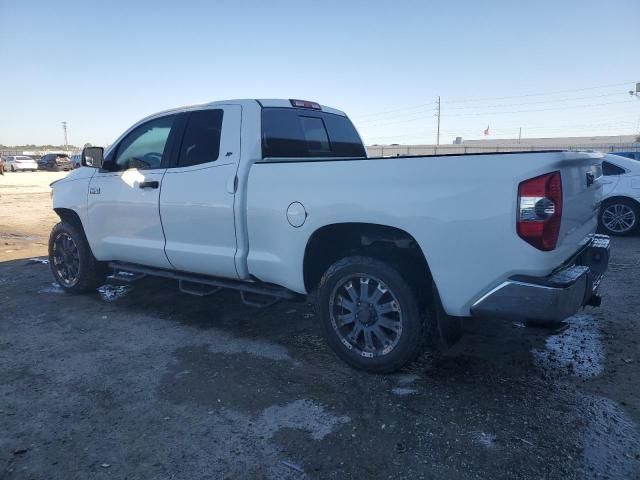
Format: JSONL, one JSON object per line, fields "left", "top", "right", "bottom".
{"left": 316, "top": 256, "right": 433, "bottom": 373}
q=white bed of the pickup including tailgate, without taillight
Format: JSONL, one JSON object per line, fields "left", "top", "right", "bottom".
{"left": 246, "top": 150, "right": 601, "bottom": 316}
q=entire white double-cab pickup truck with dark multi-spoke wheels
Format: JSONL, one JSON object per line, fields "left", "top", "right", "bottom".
{"left": 49, "top": 100, "right": 609, "bottom": 372}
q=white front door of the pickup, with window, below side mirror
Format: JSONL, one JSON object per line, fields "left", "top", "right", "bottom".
{"left": 88, "top": 115, "right": 178, "bottom": 268}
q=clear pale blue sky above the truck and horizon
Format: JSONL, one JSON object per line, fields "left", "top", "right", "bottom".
{"left": 0, "top": 0, "right": 640, "bottom": 145}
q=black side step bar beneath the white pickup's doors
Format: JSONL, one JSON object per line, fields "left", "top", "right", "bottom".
{"left": 109, "top": 262, "right": 300, "bottom": 307}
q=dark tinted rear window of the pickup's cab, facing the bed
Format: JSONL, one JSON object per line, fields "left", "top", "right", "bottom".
{"left": 262, "top": 108, "right": 366, "bottom": 158}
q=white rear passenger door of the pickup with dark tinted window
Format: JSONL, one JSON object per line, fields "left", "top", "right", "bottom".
{"left": 160, "top": 105, "right": 242, "bottom": 278}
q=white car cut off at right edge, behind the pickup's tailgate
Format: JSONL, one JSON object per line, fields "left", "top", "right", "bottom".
{"left": 598, "top": 152, "right": 640, "bottom": 235}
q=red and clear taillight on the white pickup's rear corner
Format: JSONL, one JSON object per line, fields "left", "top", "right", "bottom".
{"left": 516, "top": 172, "right": 562, "bottom": 251}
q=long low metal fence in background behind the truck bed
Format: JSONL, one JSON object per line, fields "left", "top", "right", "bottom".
{"left": 367, "top": 143, "right": 640, "bottom": 157}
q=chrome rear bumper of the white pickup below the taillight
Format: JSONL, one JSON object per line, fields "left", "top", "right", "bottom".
{"left": 471, "top": 235, "right": 609, "bottom": 323}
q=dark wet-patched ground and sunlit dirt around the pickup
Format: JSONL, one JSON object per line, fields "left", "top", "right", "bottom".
{"left": 0, "top": 172, "right": 640, "bottom": 480}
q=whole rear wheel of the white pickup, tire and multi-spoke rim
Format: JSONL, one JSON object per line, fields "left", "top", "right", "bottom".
{"left": 317, "top": 256, "right": 432, "bottom": 372}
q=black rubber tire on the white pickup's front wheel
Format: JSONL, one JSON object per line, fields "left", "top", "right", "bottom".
{"left": 49, "top": 221, "right": 108, "bottom": 294}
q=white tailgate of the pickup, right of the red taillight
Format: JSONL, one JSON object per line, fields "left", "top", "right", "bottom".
{"left": 558, "top": 152, "right": 602, "bottom": 247}
